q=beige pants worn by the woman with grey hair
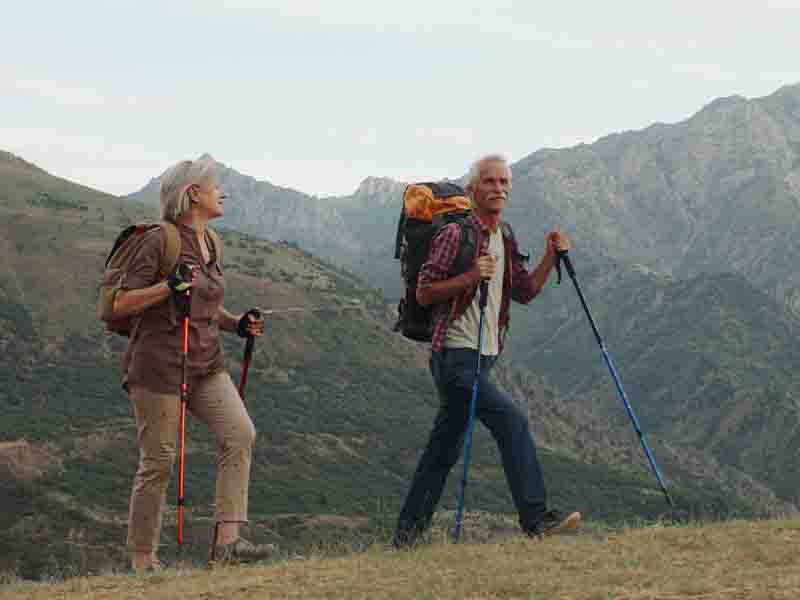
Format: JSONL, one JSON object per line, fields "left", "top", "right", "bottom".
{"left": 128, "top": 372, "right": 256, "bottom": 552}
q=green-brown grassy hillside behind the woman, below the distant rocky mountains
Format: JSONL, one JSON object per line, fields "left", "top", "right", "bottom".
{"left": 0, "top": 155, "right": 757, "bottom": 577}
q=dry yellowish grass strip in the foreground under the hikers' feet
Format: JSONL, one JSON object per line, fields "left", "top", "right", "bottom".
{"left": 6, "top": 520, "right": 800, "bottom": 600}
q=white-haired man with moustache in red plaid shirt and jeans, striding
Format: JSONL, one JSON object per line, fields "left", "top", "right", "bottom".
{"left": 392, "top": 155, "right": 581, "bottom": 548}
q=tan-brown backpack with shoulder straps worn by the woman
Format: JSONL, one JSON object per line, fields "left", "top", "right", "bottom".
{"left": 97, "top": 221, "right": 222, "bottom": 337}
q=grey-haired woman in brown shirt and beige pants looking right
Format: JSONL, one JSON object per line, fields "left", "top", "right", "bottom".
{"left": 113, "top": 160, "right": 272, "bottom": 570}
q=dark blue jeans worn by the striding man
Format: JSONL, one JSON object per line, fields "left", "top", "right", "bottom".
{"left": 394, "top": 349, "right": 546, "bottom": 546}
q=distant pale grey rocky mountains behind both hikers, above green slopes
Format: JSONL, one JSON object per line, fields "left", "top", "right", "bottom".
{"left": 126, "top": 85, "right": 800, "bottom": 312}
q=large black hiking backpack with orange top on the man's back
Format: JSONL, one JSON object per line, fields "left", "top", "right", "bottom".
{"left": 394, "top": 182, "right": 477, "bottom": 342}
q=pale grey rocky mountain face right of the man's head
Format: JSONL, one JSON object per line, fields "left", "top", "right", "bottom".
{"left": 509, "top": 86, "right": 800, "bottom": 304}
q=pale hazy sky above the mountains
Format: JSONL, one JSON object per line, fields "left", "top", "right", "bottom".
{"left": 0, "top": 0, "right": 800, "bottom": 195}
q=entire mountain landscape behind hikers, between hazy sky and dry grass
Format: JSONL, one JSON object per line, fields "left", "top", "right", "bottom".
{"left": 0, "top": 86, "right": 800, "bottom": 576}
